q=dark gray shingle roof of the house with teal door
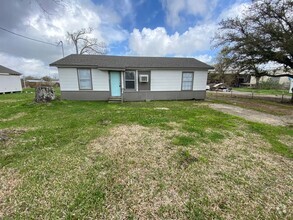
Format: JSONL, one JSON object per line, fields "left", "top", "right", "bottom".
{"left": 50, "top": 54, "right": 213, "bottom": 69}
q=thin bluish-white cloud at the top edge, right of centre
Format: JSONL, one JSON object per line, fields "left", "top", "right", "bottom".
{"left": 161, "top": 0, "right": 218, "bottom": 27}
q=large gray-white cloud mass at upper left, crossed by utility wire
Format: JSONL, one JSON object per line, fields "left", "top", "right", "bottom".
{"left": 0, "top": 0, "right": 130, "bottom": 75}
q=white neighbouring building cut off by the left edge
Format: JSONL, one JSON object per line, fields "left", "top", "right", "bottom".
{"left": 0, "top": 65, "right": 22, "bottom": 93}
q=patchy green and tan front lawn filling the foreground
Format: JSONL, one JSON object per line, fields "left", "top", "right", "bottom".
{"left": 0, "top": 90, "right": 293, "bottom": 219}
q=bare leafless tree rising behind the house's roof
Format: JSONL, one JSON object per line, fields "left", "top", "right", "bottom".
{"left": 67, "top": 28, "right": 107, "bottom": 54}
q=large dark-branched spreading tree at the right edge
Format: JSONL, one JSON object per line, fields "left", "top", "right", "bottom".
{"left": 215, "top": 0, "right": 293, "bottom": 77}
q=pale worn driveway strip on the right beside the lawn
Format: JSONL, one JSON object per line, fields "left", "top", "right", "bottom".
{"left": 209, "top": 104, "right": 293, "bottom": 126}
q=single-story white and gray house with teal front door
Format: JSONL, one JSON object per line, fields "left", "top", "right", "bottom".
{"left": 50, "top": 54, "right": 213, "bottom": 101}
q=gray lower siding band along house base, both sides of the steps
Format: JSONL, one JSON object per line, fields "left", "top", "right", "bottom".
{"left": 61, "top": 90, "right": 206, "bottom": 101}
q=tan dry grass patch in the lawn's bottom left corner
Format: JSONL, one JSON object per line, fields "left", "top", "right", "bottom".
{"left": 0, "top": 168, "right": 21, "bottom": 219}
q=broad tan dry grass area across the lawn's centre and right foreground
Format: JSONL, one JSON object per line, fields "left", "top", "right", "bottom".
{"left": 89, "top": 123, "right": 293, "bottom": 219}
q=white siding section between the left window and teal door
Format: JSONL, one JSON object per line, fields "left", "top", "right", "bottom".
{"left": 92, "top": 69, "right": 109, "bottom": 91}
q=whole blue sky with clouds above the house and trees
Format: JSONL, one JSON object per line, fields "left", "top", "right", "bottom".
{"left": 0, "top": 0, "right": 251, "bottom": 77}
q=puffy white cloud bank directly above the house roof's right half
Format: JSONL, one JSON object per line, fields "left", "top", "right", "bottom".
{"left": 129, "top": 24, "right": 216, "bottom": 56}
